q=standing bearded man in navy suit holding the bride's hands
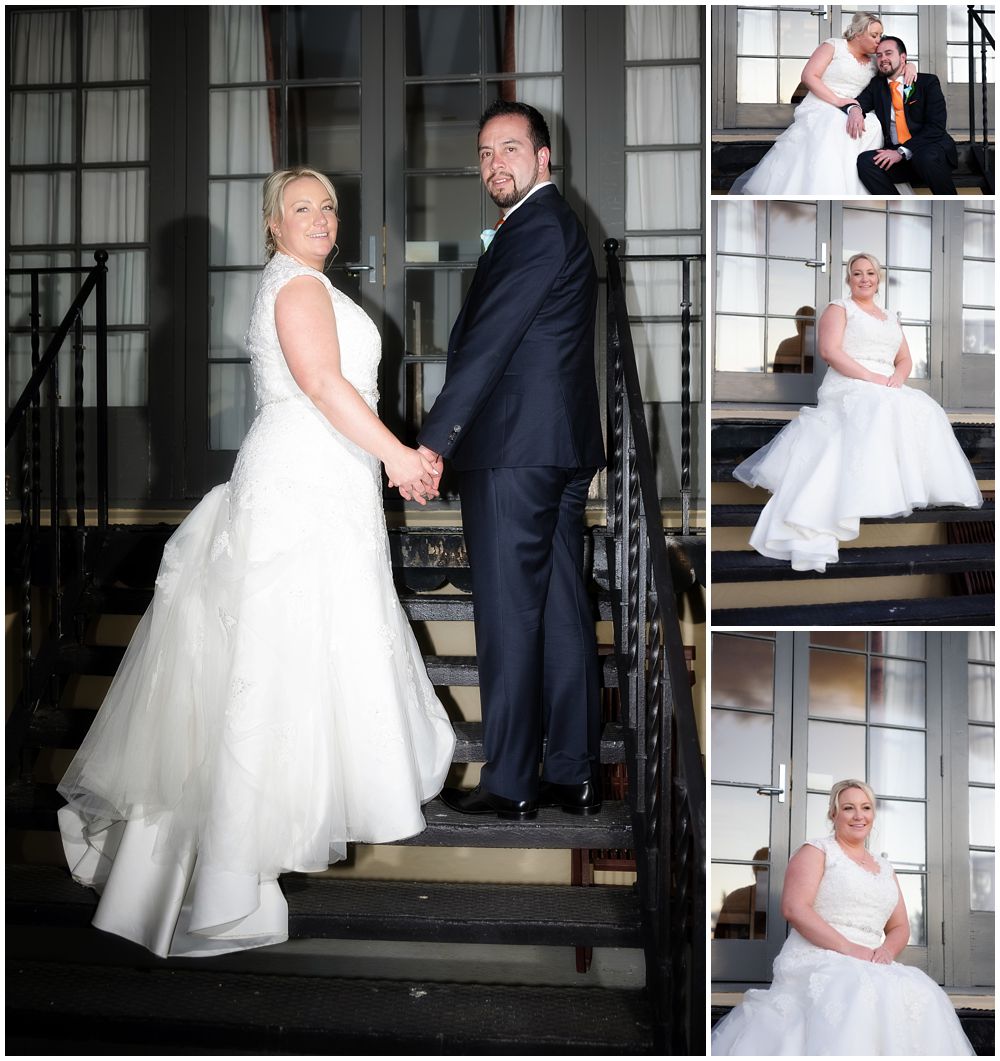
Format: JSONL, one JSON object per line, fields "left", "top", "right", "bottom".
{"left": 418, "top": 100, "right": 604, "bottom": 820}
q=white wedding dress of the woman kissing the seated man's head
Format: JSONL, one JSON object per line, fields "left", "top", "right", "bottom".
{"left": 730, "top": 37, "right": 882, "bottom": 197}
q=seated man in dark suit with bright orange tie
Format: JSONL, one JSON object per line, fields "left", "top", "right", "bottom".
{"left": 844, "top": 37, "right": 959, "bottom": 195}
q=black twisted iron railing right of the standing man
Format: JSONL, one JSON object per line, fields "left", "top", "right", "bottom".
{"left": 604, "top": 240, "right": 706, "bottom": 1055}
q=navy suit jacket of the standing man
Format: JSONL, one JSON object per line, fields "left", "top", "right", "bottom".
{"left": 418, "top": 185, "right": 604, "bottom": 471}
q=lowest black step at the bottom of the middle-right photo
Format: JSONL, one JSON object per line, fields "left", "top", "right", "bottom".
{"left": 712, "top": 593, "right": 996, "bottom": 629}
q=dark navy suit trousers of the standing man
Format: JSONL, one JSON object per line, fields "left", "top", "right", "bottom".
{"left": 458, "top": 467, "right": 600, "bottom": 800}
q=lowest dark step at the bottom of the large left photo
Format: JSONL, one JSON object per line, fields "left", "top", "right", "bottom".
{"left": 5, "top": 961, "right": 652, "bottom": 1056}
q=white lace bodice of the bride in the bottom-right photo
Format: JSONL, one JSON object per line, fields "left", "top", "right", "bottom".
{"left": 808, "top": 836, "right": 899, "bottom": 947}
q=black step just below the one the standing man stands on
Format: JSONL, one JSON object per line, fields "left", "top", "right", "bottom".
{"left": 5, "top": 866, "right": 642, "bottom": 946}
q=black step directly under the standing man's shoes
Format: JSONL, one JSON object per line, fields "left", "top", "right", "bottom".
{"left": 6, "top": 781, "right": 632, "bottom": 850}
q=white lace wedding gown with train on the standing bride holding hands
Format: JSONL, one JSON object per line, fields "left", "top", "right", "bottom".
{"left": 58, "top": 254, "right": 455, "bottom": 957}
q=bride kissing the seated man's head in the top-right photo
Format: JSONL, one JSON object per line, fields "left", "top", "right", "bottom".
{"left": 730, "top": 12, "right": 916, "bottom": 197}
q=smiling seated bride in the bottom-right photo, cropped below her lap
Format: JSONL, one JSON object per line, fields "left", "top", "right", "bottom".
{"left": 712, "top": 779, "right": 975, "bottom": 1057}
